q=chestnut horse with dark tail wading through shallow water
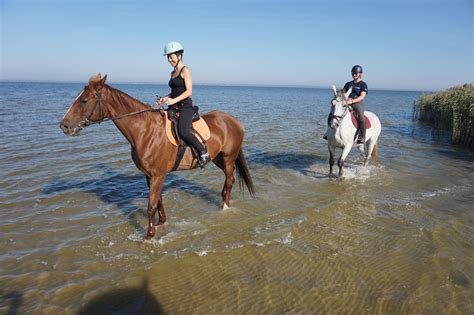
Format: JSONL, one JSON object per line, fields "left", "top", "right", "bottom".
{"left": 60, "top": 74, "right": 255, "bottom": 240}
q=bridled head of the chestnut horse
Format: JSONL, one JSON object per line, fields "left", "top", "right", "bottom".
{"left": 59, "top": 73, "right": 107, "bottom": 136}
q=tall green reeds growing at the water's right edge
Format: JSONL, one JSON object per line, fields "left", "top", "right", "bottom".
{"left": 414, "top": 83, "right": 474, "bottom": 147}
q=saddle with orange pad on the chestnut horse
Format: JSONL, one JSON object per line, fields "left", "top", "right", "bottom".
{"left": 165, "top": 106, "right": 211, "bottom": 171}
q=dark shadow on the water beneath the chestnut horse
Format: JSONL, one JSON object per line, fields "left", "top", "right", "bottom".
{"left": 43, "top": 164, "right": 221, "bottom": 230}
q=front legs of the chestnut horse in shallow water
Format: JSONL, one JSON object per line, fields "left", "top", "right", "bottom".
{"left": 145, "top": 176, "right": 166, "bottom": 241}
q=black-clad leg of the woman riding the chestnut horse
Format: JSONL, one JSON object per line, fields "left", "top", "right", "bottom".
{"left": 178, "top": 105, "right": 211, "bottom": 166}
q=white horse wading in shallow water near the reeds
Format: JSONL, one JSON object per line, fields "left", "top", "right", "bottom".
{"left": 326, "top": 85, "right": 382, "bottom": 177}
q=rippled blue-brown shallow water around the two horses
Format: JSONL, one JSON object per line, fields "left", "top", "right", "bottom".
{"left": 0, "top": 82, "right": 474, "bottom": 314}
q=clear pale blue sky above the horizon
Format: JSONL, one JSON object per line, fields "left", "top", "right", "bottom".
{"left": 0, "top": 0, "right": 474, "bottom": 91}
